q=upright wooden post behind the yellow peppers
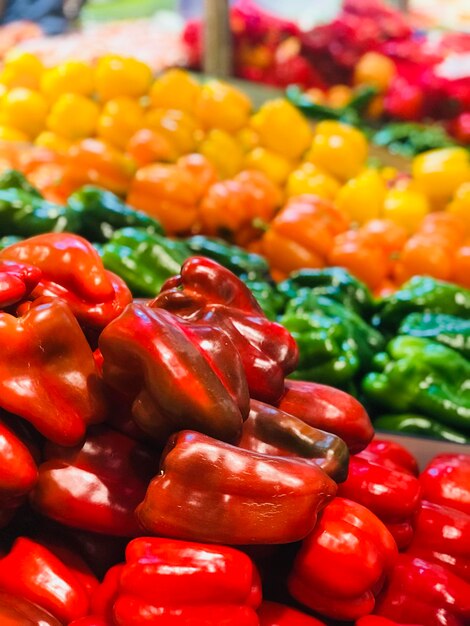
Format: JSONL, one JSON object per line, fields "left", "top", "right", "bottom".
{"left": 204, "top": 0, "right": 233, "bottom": 78}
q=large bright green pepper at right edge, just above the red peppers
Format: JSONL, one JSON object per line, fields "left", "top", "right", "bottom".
{"left": 362, "top": 335, "right": 470, "bottom": 434}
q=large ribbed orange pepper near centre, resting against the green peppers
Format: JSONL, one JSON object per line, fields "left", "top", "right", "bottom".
{"left": 262, "top": 194, "right": 347, "bottom": 274}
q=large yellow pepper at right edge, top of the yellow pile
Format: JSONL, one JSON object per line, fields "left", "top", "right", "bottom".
{"left": 412, "top": 148, "right": 470, "bottom": 205}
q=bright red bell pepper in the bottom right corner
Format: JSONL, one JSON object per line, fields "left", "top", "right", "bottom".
{"left": 374, "top": 554, "right": 470, "bottom": 626}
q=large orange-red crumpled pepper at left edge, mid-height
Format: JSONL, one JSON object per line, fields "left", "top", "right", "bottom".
{"left": 0, "top": 300, "right": 106, "bottom": 445}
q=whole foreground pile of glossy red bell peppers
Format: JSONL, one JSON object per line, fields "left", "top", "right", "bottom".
{"left": 0, "top": 233, "right": 470, "bottom": 626}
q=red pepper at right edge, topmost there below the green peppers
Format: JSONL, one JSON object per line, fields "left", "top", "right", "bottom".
{"left": 419, "top": 454, "right": 470, "bottom": 515}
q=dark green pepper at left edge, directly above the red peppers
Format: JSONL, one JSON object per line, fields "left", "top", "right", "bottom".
{"left": 0, "top": 187, "right": 80, "bottom": 237}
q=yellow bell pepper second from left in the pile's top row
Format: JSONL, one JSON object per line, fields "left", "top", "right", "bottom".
{"left": 41, "top": 60, "right": 94, "bottom": 102}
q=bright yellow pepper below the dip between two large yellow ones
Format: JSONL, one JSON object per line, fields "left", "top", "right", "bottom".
{"left": 335, "top": 169, "right": 387, "bottom": 224}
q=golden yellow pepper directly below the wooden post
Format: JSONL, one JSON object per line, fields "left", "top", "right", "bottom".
{"left": 194, "top": 80, "right": 251, "bottom": 133}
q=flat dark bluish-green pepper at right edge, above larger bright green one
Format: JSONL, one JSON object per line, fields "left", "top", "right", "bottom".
{"left": 398, "top": 313, "right": 470, "bottom": 359}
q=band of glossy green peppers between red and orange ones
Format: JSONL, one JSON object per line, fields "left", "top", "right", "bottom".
{"left": 0, "top": 171, "right": 470, "bottom": 443}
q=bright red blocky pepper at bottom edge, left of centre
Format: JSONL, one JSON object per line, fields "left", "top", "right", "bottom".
{"left": 114, "top": 537, "right": 258, "bottom": 626}
